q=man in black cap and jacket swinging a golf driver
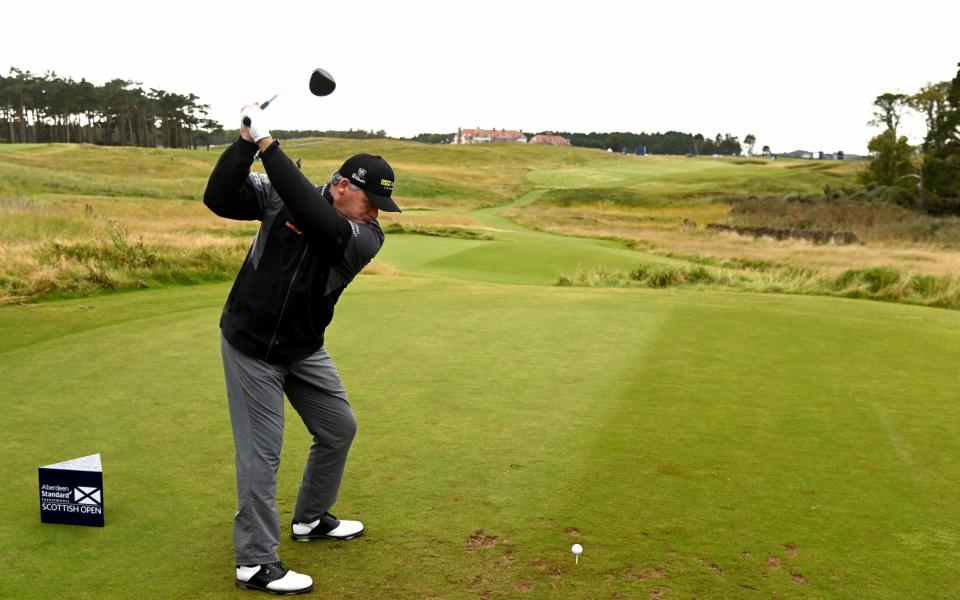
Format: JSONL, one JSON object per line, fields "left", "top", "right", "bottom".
{"left": 203, "top": 106, "right": 400, "bottom": 594}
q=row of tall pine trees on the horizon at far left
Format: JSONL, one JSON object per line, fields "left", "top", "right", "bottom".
{"left": 0, "top": 68, "right": 223, "bottom": 148}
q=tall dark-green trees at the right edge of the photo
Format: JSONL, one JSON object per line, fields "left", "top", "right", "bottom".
{"left": 863, "top": 63, "right": 960, "bottom": 214}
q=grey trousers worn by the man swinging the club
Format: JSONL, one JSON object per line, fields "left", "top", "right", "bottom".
{"left": 220, "top": 336, "right": 357, "bottom": 565}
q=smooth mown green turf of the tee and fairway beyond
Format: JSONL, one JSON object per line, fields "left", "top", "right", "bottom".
{"left": 0, "top": 146, "right": 960, "bottom": 599}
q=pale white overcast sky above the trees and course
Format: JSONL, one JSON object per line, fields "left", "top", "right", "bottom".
{"left": 0, "top": 0, "right": 960, "bottom": 153}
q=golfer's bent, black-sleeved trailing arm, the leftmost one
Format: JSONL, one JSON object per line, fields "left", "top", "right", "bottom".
{"left": 203, "top": 139, "right": 263, "bottom": 221}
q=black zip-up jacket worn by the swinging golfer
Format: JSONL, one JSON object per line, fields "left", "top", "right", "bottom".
{"left": 203, "top": 140, "right": 384, "bottom": 363}
